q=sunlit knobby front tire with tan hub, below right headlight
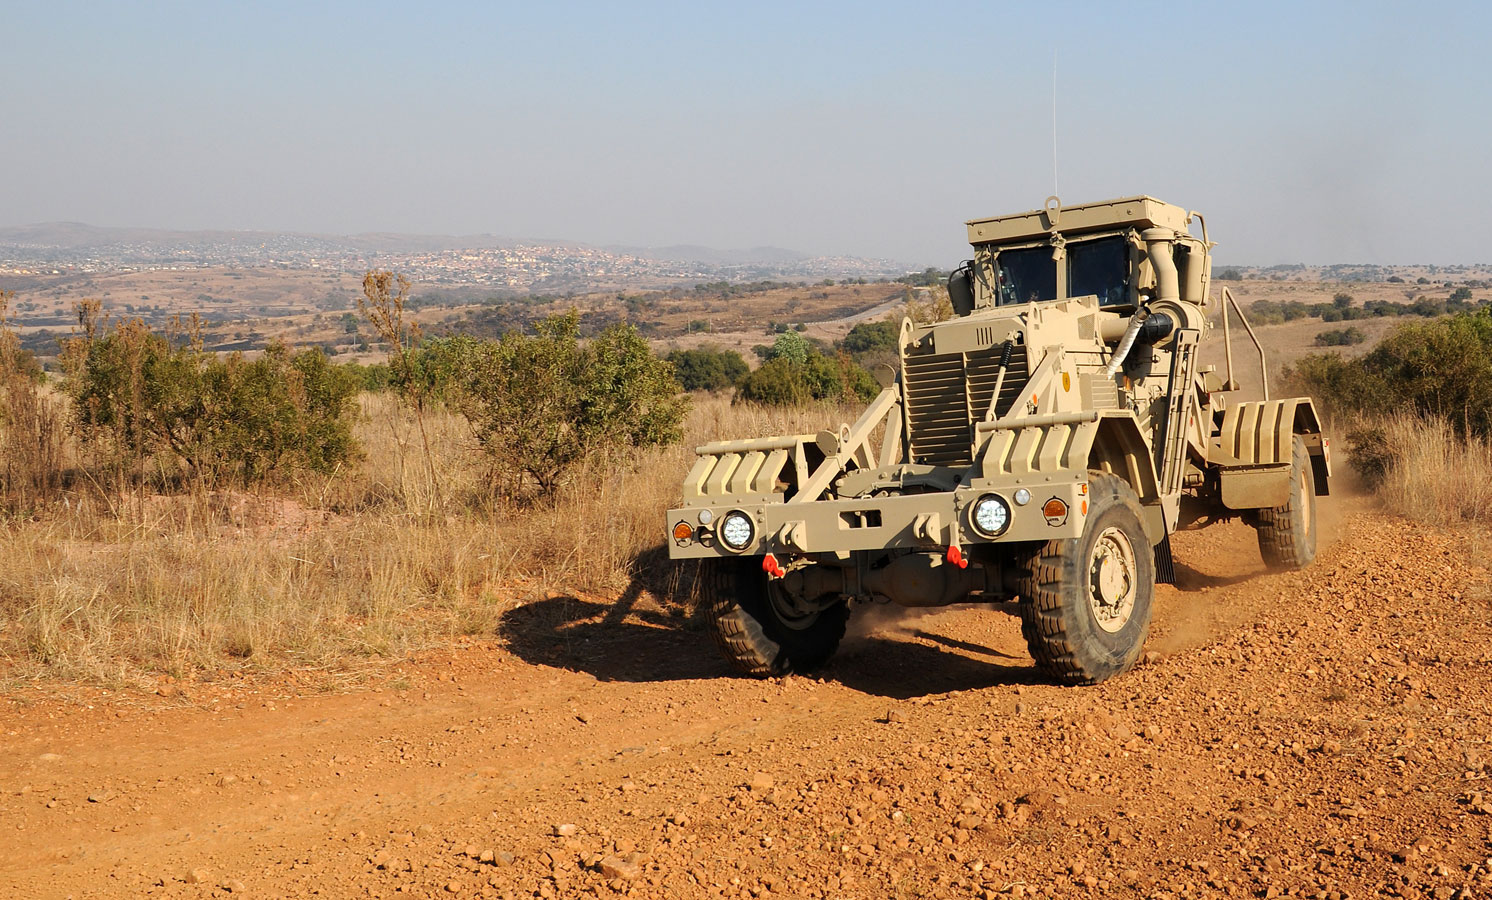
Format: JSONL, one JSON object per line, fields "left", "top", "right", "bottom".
{"left": 1018, "top": 472, "right": 1155, "bottom": 685}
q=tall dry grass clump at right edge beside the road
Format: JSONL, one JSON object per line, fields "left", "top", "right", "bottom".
{"left": 1349, "top": 415, "right": 1492, "bottom": 525}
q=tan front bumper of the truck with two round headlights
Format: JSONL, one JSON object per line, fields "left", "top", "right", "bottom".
{"left": 665, "top": 481, "right": 1088, "bottom": 560}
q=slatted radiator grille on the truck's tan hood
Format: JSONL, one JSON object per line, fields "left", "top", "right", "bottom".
{"left": 906, "top": 345, "right": 1028, "bottom": 467}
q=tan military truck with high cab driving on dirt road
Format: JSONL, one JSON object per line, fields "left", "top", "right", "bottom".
{"left": 667, "top": 197, "right": 1331, "bottom": 684}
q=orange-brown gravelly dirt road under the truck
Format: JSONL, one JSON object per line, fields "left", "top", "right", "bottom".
{"left": 0, "top": 500, "right": 1492, "bottom": 899}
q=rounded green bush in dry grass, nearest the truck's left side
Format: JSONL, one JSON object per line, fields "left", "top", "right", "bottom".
{"left": 427, "top": 312, "right": 688, "bottom": 496}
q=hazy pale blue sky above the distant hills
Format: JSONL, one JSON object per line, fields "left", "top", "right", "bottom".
{"left": 0, "top": 0, "right": 1492, "bottom": 267}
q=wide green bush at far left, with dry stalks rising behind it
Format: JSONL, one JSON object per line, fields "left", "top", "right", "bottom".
{"left": 63, "top": 313, "right": 358, "bottom": 485}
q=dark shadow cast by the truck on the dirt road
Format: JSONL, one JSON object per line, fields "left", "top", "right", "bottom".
{"left": 498, "top": 564, "right": 1040, "bottom": 699}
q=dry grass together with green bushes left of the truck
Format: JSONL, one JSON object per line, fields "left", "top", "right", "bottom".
{"left": 0, "top": 273, "right": 858, "bottom": 684}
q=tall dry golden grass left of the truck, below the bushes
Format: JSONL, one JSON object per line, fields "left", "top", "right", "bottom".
{"left": 0, "top": 394, "right": 855, "bottom": 684}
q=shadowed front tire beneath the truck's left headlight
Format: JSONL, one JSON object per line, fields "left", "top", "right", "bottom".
{"left": 701, "top": 557, "right": 849, "bottom": 678}
